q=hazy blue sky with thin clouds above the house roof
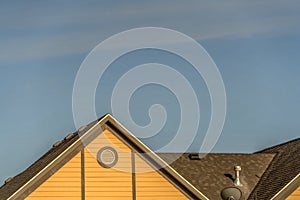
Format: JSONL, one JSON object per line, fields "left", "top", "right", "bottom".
{"left": 0, "top": 1, "right": 300, "bottom": 182}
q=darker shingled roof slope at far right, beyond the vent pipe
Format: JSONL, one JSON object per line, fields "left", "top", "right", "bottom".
{"left": 249, "top": 138, "right": 300, "bottom": 199}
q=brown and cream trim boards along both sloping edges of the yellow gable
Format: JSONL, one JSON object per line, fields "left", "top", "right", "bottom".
{"left": 7, "top": 114, "right": 208, "bottom": 200}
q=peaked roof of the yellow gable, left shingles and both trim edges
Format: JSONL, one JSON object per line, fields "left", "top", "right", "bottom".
{"left": 0, "top": 114, "right": 208, "bottom": 200}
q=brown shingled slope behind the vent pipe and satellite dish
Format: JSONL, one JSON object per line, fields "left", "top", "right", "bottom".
{"left": 158, "top": 153, "right": 275, "bottom": 200}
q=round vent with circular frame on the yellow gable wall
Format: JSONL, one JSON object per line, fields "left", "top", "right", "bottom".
{"left": 97, "top": 146, "right": 118, "bottom": 168}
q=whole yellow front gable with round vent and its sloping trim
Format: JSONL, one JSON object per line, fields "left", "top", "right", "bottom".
{"left": 3, "top": 116, "right": 206, "bottom": 199}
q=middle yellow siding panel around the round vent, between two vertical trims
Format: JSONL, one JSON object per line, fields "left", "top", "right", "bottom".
{"left": 84, "top": 130, "right": 132, "bottom": 200}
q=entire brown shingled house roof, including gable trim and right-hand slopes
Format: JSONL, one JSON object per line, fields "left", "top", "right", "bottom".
{"left": 0, "top": 115, "right": 300, "bottom": 200}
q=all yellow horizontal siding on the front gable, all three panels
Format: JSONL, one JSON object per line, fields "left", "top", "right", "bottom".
{"left": 26, "top": 130, "right": 187, "bottom": 200}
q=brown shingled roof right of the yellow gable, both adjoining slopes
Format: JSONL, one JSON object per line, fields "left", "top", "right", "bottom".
{"left": 159, "top": 138, "right": 300, "bottom": 200}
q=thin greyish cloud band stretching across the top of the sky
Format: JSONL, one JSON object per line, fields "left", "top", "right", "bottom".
{"left": 0, "top": 1, "right": 300, "bottom": 62}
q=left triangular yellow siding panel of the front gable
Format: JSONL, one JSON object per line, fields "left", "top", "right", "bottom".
{"left": 26, "top": 153, "right": 81, "bottom": 200}
